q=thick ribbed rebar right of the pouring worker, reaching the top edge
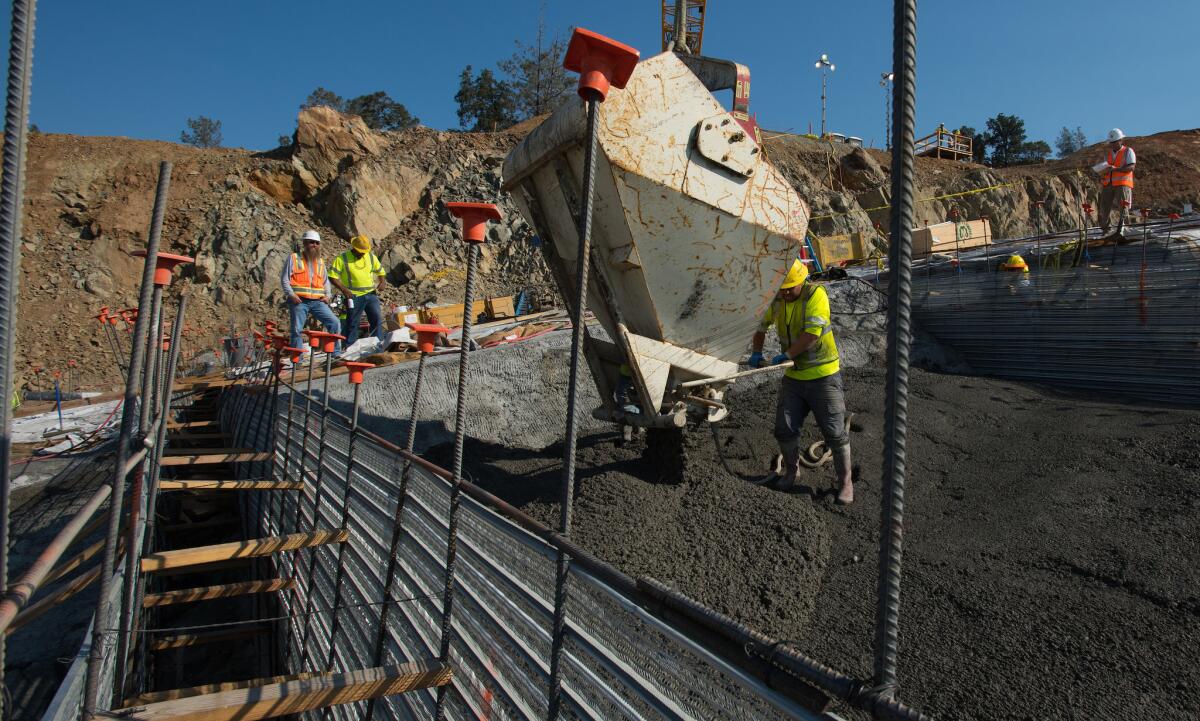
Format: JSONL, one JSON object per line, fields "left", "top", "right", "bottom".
{"left": 875, "top": 0, "right": 912, "bottom": 698}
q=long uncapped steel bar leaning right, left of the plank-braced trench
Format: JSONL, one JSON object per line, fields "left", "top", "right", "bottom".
{"left": 83, "top": 161, "right": 172, "bottom": 721}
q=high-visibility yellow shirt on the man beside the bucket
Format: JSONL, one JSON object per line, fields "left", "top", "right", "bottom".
{"left": 758, "top": 281, "right": 841, "bottom": 380}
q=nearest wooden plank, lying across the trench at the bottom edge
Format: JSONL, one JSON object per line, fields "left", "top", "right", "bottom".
{"left": 104, "top": 659, "right": 454, "bottom": 721}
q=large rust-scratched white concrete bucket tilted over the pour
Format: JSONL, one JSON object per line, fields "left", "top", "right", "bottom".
{"left": 504, "top": 53, "right": 809, "bottom": 425}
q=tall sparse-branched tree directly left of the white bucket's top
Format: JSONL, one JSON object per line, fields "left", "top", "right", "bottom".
{"left": 497, "top": 17, "right": 576, "bottom": 120}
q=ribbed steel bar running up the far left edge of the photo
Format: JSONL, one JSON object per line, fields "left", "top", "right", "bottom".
{"left": 0, "top": 0, "right": 37, "bottom": 695}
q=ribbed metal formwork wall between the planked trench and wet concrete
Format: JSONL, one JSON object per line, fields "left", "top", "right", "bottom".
{"left": 223, "top": 391, "right": 830, "bottom": 721}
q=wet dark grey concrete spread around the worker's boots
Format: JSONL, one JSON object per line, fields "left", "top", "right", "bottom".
{"left": 430, "top": 368, "right": 1200, "bottom": 720}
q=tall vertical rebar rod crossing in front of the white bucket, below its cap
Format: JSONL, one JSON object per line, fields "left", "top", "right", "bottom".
{"left": 546, "top": 96, "right": 600, "bottom": 721}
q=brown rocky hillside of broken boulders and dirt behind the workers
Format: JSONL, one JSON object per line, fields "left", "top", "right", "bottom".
{"left": 17, "top": 108, "right": 1200, "bottom": 389}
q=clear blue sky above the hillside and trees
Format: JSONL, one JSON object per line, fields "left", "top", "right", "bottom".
{"left": 16, "top": 0, "right": 1200, "bottom": 149}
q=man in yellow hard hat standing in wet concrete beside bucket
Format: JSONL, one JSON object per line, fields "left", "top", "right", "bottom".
{"left": 750, "top": 260, "right": 854, "bottom": 504}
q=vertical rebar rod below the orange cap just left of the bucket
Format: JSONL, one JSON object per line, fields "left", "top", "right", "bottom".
{"left": 433, "top": 242, "right": 479, "bottom": 721}
